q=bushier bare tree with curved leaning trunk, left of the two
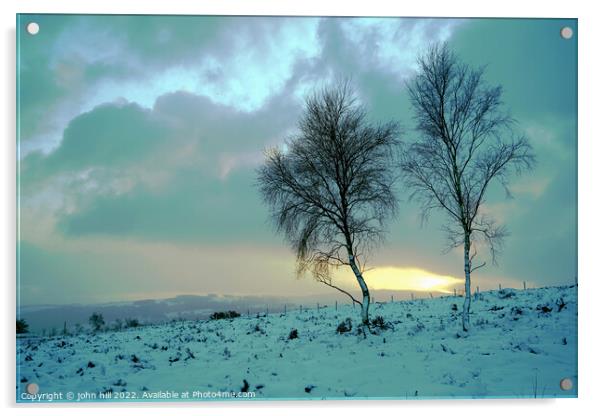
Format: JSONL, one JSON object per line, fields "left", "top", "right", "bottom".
{"left": 258, "top": 82, "right": 399, "bottom": 324}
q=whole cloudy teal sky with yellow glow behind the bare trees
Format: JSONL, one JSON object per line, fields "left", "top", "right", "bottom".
{"left": 17, "top": 15, "right": 577, "bottom": 305}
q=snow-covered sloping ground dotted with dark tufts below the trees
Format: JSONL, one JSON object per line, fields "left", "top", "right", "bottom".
{"left": 17, "top": 286, "right": 577, "bottom": 402}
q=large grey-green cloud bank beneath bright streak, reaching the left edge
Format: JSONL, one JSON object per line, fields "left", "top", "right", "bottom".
{"left": 21, "top": 88, "right": 300, "bottom": 242}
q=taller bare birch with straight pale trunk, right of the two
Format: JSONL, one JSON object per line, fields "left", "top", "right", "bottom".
{"left": 401, "top": 44, "right": 535, "bottom": 331}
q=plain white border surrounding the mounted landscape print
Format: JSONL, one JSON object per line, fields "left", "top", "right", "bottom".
{"left": 0, "top": 0, "right": 602, "bottom": 416}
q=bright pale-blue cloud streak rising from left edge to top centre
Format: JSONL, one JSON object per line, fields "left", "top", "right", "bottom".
{"left": 21, "top": 18, "right": 321, "bottom": 156}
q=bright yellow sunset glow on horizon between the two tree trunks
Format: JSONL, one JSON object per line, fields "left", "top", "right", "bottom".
{"left": 358, "top": 267, "right": 463, "bottom": 293}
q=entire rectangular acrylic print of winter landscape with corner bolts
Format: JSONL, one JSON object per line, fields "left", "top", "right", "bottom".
{"left": 15, "top": 15, "right": 578, "bottom": 403}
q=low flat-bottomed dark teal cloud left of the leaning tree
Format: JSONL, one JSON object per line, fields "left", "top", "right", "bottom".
{"left": 58, "top": 169, "right": 272, "bottom": 243}
